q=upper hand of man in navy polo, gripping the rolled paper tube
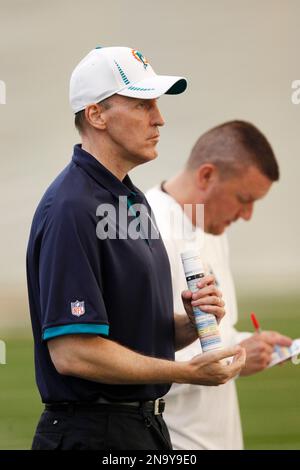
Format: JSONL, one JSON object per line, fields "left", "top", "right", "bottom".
{"left": 181, "top": 275, "right": 225, "bottom": 325}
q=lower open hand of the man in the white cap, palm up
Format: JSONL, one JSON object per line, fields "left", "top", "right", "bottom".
{"left": 186, "top": 346, "right": 246, "bottom": 386}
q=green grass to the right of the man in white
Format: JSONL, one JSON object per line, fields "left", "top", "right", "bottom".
{"left": 237, "top": 297, "right": 300, "bottom": 449}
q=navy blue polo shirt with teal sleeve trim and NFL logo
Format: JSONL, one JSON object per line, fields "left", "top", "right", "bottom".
{"left": 27, "top": 145, "right": 174, "bottom": 403}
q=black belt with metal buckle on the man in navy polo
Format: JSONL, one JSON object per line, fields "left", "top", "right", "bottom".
{"left": 45, "top": 397, "right": 165, "bottom": 415}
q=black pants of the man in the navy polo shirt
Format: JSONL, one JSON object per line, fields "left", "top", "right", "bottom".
{"left": 32, "top": 405, "right": 172, "bottom": 450}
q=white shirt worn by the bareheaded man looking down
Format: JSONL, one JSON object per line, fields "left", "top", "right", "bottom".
{"left": 146, "top": 187, "right": 249, "bottom": 450}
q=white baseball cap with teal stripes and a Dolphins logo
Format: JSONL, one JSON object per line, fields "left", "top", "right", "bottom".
{"left": 70, "top": 47, "right": 187, "bottom": 113}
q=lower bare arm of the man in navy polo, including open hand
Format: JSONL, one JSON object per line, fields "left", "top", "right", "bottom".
{"left": 48, "top": 335, "right": 245, "bottom": 385}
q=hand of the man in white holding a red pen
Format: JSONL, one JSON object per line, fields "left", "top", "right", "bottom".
{"left": 240, "top": 331, "right": 292, "bottom": 376}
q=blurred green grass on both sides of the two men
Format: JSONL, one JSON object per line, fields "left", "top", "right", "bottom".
{"left": 0, "top": 296, "right": 300, "bottom": 450}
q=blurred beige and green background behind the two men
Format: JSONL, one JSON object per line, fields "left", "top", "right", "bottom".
{"left": 0, "top": 0, "right": 300, "bottom": 449}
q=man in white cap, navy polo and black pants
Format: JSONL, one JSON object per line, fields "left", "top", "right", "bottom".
{"left": 27, "top": 47, "right": 245, "bottom": 450}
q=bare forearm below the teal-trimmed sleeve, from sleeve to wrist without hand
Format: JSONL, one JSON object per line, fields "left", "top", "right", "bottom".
{"left": 49, "top": 336, "right": 187, "bottom": 384}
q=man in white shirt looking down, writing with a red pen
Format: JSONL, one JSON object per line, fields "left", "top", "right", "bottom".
{"left": 146, "top": 121, "right": 291, "bottom": 450}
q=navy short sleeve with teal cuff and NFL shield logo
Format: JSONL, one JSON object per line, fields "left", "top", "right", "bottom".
{"left": 39, "top": 202, "right": 109, "bottom": 340}
